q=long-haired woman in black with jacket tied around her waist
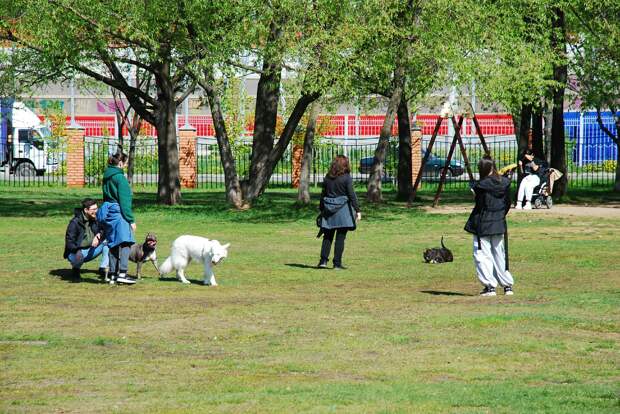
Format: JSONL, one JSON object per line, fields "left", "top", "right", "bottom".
{"left": 318, "top": 155, "right": 362, "bottom": 270}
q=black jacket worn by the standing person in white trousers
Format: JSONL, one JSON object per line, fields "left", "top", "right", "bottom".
{"left": 465, "top": 177, "right": 511, "bottom": 237}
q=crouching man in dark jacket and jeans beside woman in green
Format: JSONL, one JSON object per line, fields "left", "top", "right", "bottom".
{"left": 63, "top": 198, "right": 109, "bottom": 279}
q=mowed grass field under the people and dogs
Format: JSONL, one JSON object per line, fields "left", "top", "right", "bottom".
{"left": 0, "top": 188, "right": 620, "bottom": 413}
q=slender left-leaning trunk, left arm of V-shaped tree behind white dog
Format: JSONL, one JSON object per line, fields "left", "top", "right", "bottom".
{"left": 201, "top": 72, "right": 245, "bottom": 209}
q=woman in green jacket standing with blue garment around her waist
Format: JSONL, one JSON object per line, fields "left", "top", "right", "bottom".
{"left": 97, "top": 149, "right": 136, "bottom": 284}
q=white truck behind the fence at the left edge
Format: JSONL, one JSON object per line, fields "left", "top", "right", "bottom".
{"left": 0, "top": 99, "right": 59, "bottom": 177}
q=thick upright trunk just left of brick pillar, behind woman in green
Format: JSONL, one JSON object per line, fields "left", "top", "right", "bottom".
{"left": 155, "top": 77, "right": 181, "bottom": 205}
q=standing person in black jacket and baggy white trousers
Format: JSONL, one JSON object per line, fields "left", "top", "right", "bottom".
{"left": 465, "top": 155, "right": 514, "bottom": 296}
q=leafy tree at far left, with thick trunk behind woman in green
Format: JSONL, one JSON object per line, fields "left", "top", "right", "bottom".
{"left": 0, "top": 0, "right": 237, "bottom": 204}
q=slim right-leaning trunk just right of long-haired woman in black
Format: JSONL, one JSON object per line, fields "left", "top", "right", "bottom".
{"left": 366, "top": 66, "right": 405, "bottom": 203}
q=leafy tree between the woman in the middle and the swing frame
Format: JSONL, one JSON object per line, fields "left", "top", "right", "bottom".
{"left": 352, "top": 0, "right": 463, "bottom": 202}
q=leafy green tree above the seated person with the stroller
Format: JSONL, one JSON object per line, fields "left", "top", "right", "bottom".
{"left": 452, "top": 0, "right": 566, "bottom": 194}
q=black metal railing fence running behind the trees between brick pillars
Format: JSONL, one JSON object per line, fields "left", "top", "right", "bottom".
{"left": 0, "top": 135, "right": 617, "bottom": 189}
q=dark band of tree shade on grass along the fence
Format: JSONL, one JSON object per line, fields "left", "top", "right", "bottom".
{"left": 0, "top": 188, "right": 471, "bottom": 222}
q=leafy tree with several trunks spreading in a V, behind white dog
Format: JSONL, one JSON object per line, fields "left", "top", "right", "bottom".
{"left": 195, "top": 0, "right": 350, "bottom": 208}
